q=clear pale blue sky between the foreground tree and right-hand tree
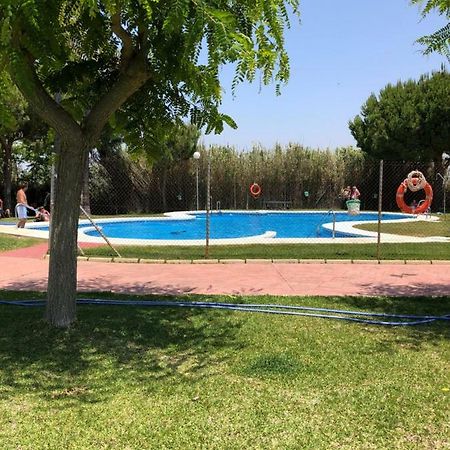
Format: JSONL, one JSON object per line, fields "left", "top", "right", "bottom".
{"left": 202, "top": 0, "right": 446, "bottom": 150}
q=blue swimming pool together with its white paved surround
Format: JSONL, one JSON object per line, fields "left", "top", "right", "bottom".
{"left": 0, "top": 210, "right": 442, "bottom": 246}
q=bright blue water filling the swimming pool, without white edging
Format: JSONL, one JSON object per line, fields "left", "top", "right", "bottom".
{"left": 77, "top": 212, "right": 408, "bottom": 240}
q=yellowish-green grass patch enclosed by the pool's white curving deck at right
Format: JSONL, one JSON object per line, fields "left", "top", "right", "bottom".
{"left": 355, "top": 214, "right": 450, "bottom": 237}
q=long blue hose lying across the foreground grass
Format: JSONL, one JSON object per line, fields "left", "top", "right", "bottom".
{"left": 0, "top": 298, "right": 450, "bottom": 326}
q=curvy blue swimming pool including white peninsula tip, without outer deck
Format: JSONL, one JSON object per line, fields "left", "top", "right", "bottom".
{"left": 73, "top": 211, "right": 411, "bottom": 243}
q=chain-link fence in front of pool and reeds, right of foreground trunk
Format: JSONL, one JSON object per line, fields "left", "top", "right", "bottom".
{"left": 72, "top": 146, "right": 450, "bottom": 260}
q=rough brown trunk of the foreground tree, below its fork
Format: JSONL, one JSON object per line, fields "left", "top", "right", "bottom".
{"left": 45, "top": 139, "right": 88, "bottom": 327}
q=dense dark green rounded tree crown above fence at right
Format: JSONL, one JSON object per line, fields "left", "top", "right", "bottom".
{"left": 349, "top": 71, "right": 450, "bottom": 161}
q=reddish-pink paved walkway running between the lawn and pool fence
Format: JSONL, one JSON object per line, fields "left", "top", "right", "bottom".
{"left": 0, "top": 244, "right": 450, "bottom": 296}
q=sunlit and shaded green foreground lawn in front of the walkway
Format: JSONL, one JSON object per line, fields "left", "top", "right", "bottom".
{"left": 0, "top": 292, "right": 450, "bottom": 450}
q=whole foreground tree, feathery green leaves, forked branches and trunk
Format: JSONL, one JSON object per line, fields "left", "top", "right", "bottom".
{"left": 0, "top": 0, "right": 299, "bottom": 326}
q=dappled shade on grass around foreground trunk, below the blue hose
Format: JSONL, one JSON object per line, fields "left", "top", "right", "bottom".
{"left": 0, "top": 296, "right": 241, "bottom": 407}
